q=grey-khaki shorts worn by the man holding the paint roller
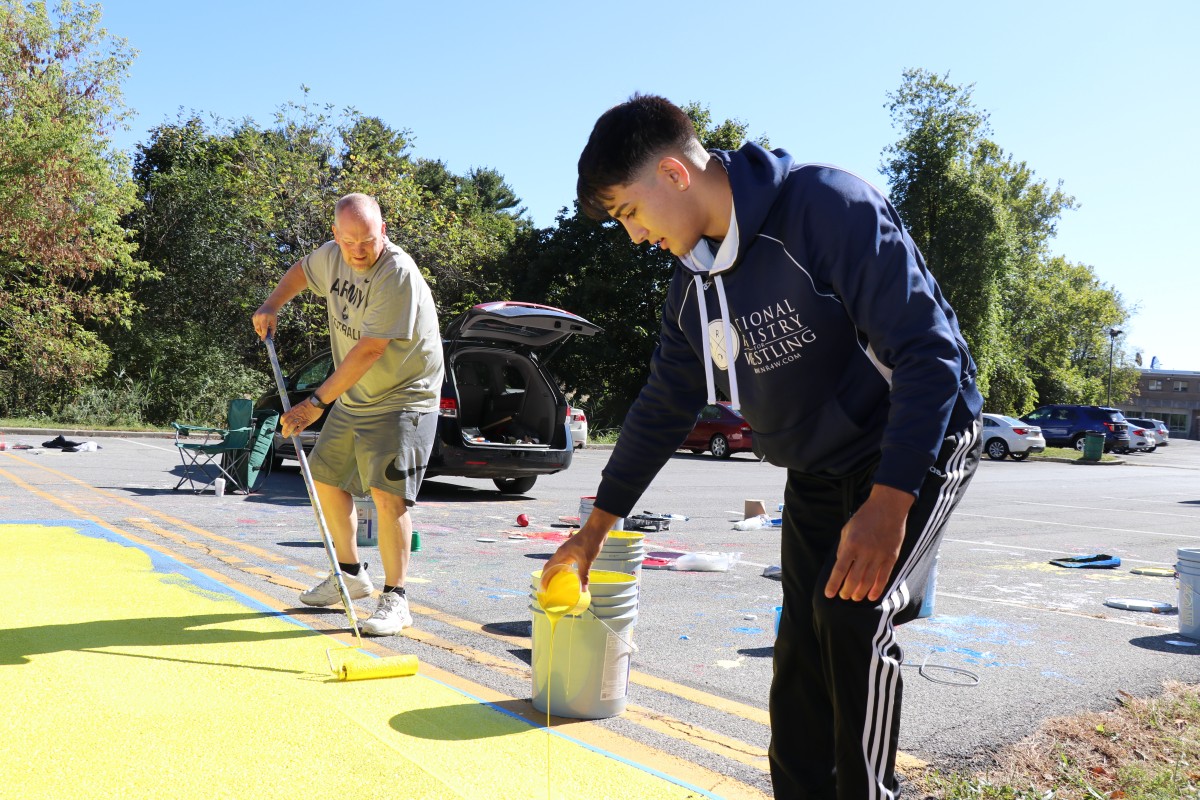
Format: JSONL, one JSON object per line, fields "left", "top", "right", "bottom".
{"left": 308, "top": 404, "right": 438, "bottom": 505}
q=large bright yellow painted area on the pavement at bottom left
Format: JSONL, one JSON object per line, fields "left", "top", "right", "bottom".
{"left": 0, "top": 522, "right": 712, "bottom": 800}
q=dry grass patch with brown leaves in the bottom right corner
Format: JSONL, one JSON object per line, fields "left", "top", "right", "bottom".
{"left": 905, "top": 682, "right": 1200, "bottom": 800}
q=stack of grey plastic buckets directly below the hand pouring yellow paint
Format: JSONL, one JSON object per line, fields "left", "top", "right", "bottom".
{"left": 529, "top": 570, "right": 637, "bottom": 720}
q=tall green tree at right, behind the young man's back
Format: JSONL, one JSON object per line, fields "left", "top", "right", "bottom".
{"left": 882, "top": 70, "right": 1128, "bottom": 414}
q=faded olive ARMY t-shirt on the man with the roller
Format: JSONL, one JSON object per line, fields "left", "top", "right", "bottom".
{"left": 301, "top": 240, "right": 443, "bottom": 414}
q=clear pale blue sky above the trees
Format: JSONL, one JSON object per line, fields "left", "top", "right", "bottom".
{"left": 102, "top": 0, "right": 1200, "bottom": 371}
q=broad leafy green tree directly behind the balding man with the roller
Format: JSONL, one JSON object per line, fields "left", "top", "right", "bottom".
{"left": 119, "top": 103, "right": 527, "bottom": 421}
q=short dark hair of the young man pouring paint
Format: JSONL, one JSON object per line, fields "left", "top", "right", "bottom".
{"left": 575, "top": 95, "right": 697, "bottom": 219}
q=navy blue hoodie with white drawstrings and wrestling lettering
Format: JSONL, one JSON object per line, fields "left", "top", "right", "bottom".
{"left": 595, "top": 144, "right": 983, "bottom": 516}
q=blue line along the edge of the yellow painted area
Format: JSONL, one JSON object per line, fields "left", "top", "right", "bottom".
{"left": 7, "top": 519, "right": 721, "bottom": 800}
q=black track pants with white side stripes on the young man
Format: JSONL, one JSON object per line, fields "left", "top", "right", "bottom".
{"left": 770, "top": 422, "right": 982, "bottom": 800}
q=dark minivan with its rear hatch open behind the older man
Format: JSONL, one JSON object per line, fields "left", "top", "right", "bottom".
{"left": 254, "top": 301, "right": 600, "bottom": 494}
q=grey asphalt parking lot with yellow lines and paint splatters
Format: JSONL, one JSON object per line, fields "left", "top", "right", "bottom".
{"left": 0, "top": 432, "right": 1200, "bottom": 796}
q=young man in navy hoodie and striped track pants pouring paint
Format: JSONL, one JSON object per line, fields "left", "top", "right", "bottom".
{"left": 546, "top": 95, "right": 983, "bottom": 800}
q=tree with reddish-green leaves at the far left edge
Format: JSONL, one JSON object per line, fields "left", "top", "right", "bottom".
{"left": 0, "top": 0, "right": 144, "bottom": 414}
